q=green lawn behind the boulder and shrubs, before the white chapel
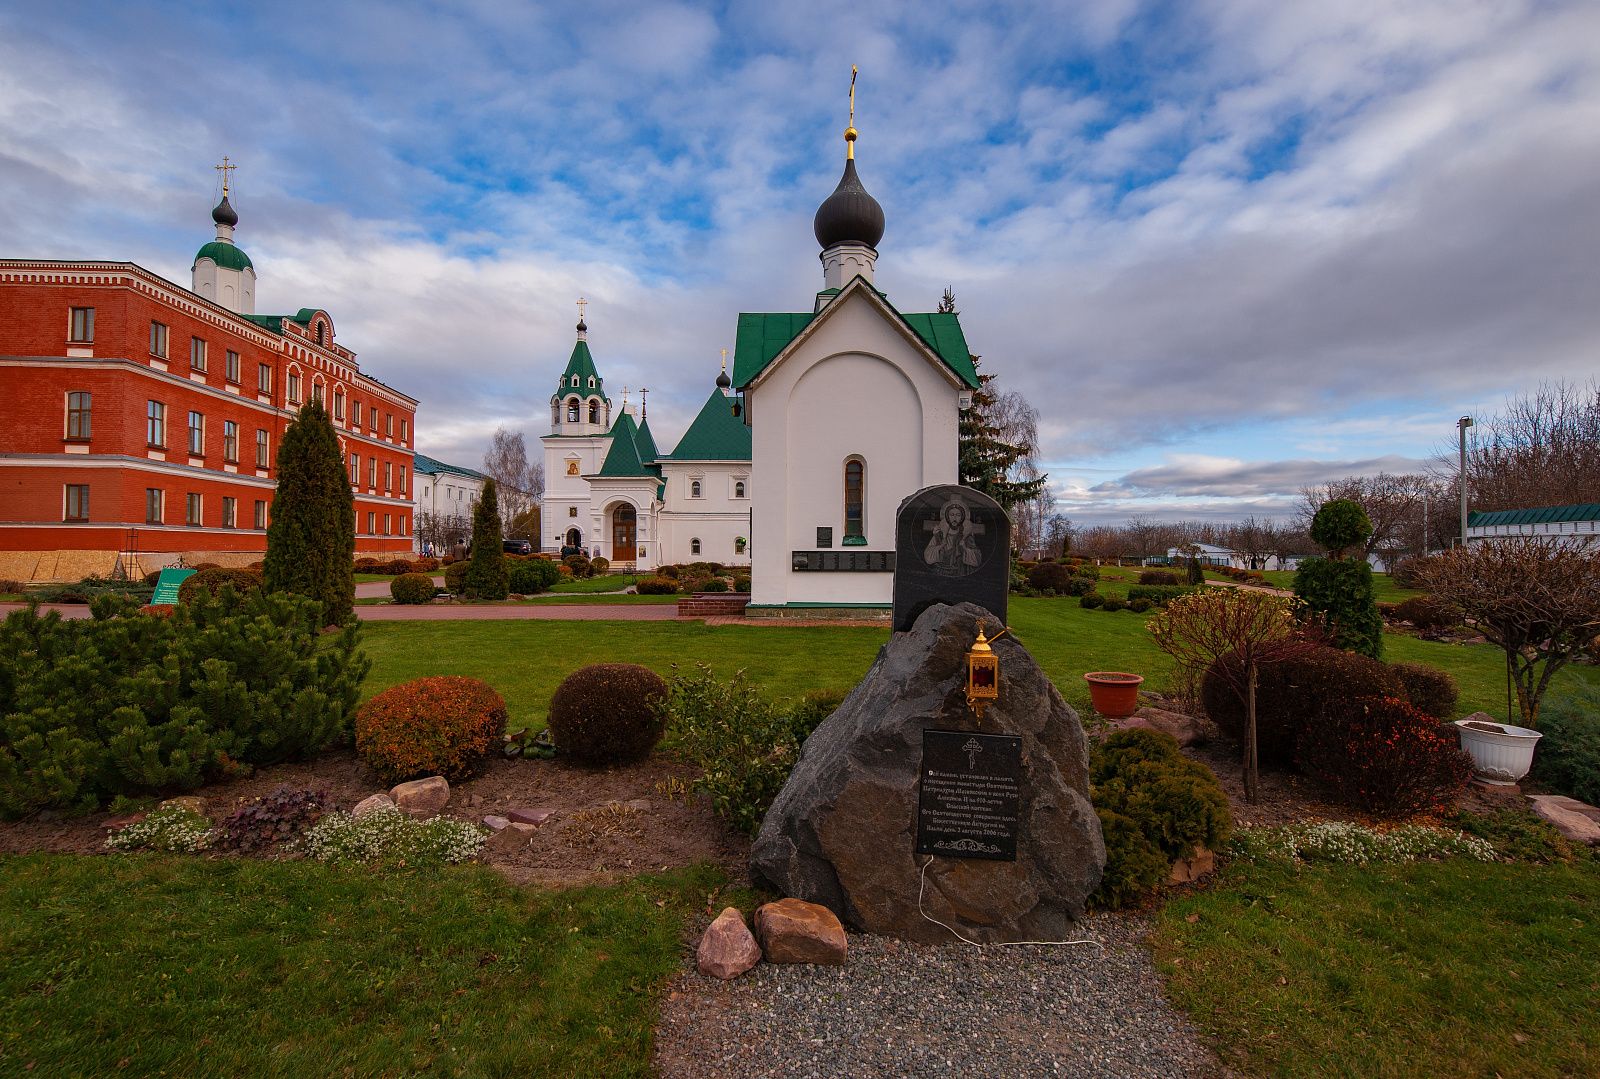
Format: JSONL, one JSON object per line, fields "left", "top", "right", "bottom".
{"left": 363, "top": 596, "right": 1600, "bottom": 727}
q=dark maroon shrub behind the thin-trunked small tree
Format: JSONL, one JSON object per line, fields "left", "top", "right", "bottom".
{"left": 1200, "top": 648, "right": 1405, "bottom": 767}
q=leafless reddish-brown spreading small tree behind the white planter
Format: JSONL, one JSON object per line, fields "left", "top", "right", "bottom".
{"left": 1418, "top": 536, "right": 1600, "bottom": 727}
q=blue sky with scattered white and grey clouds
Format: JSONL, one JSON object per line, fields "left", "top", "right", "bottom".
{"left": 0, "top": 0, "right": 1600, "bottom": 525}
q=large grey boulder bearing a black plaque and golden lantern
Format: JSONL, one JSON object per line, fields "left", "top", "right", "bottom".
{"left": 750, "top": 604, "right": 1106, "bottom": 943}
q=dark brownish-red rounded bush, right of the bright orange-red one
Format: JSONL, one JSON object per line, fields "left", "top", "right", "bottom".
{"left": 549, "top": 663, "right": 667, "bottom": 764}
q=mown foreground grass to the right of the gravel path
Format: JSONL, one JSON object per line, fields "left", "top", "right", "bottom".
{"left": 1155, "top": 860, "right": 1600, "bottom": 1077}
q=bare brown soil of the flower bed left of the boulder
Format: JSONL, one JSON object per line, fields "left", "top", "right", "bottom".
{"left": 0, "top": 751, "right": 749, "bottom": 887}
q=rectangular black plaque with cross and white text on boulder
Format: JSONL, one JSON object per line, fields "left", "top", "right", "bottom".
{"left": 917, "top": 730, "right": 1022, "bottom": 861}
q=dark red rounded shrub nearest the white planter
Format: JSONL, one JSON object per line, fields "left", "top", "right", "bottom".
{"left": 1296, "top": 696, "right": 1472, "bottom": 816}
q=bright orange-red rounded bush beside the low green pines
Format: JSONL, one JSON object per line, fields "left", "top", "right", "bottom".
{"left": 355, "top": 674, "right": 506, "bottom": 783}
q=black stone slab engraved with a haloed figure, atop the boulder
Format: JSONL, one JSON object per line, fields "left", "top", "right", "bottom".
{"left": 894, "top": 483, "right": 1011, "bottom": 632}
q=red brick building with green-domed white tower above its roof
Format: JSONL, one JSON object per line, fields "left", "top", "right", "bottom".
{"left": 0, "top": 195, "right": 416, "bottom": 581}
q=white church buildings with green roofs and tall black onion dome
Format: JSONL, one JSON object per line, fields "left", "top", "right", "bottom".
{"left": 541, "top": 111, "right": 978, "bottom": 616}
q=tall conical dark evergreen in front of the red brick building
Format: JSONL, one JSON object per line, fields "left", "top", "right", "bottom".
{"left": 261, "top": 400, "right": 355, "bottom": 626}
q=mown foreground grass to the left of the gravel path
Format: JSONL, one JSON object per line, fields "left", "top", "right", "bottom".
{"left": 0, "top": 855, "right": 722, "bottom": 1076}
